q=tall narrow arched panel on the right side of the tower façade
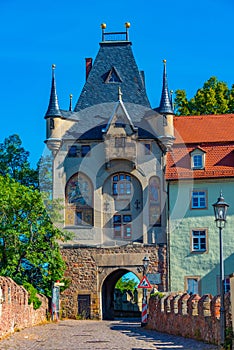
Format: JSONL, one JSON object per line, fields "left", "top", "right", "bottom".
{"left": 149, "top": 176, "right": 161, "bottom": 226}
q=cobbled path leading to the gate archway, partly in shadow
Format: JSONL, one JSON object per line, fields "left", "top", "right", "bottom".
{"left": 0, "top": 320, "right": 218, "bottom": 350}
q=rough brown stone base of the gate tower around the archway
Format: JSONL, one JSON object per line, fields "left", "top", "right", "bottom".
{"left": 61, "top": 244, "right": 167, "bottom": 319}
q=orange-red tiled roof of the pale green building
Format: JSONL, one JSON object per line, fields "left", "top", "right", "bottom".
{"left": 166, "top": 114, "right": 234, "bottom": 180}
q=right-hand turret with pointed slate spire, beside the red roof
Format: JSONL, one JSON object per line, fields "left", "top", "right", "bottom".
{"left": 157, "top": 60, "right": 175, "bottom": 150}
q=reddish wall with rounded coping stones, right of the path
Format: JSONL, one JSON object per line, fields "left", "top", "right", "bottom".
{"left": 147, "top": 293, "right": 232, "bottom": 344}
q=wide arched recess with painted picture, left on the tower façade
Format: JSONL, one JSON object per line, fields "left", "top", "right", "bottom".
{"left": 65, "top": 173, "right": 93, "bottom": 226}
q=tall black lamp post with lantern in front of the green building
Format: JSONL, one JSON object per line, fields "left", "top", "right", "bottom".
{"left": 213, "top": 192, "right": 229, "bottom": 349}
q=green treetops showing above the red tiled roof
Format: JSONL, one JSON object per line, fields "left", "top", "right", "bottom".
{"left": 174, "top": 77, "right": 234, "bottom": 115}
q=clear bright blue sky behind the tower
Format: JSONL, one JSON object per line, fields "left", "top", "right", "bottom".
{"left": 0, "top": 0, "right": 234, "bottom": 166}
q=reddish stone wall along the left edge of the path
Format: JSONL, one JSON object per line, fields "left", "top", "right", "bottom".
{"left": 0, "top": 277, "right": 48, "bottom": 339}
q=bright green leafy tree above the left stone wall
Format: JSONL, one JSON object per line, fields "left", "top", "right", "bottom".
{"left": 0, "top": 176, "right": 69, "bottom": 296}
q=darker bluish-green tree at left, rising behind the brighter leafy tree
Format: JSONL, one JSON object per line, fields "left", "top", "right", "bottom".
{"left": 0, "top": 134, "right": 38, "bottom": 188}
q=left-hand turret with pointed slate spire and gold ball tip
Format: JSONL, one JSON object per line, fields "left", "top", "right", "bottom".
{"left": 45, "top": 64, "right": 63, "bottom": 155}
